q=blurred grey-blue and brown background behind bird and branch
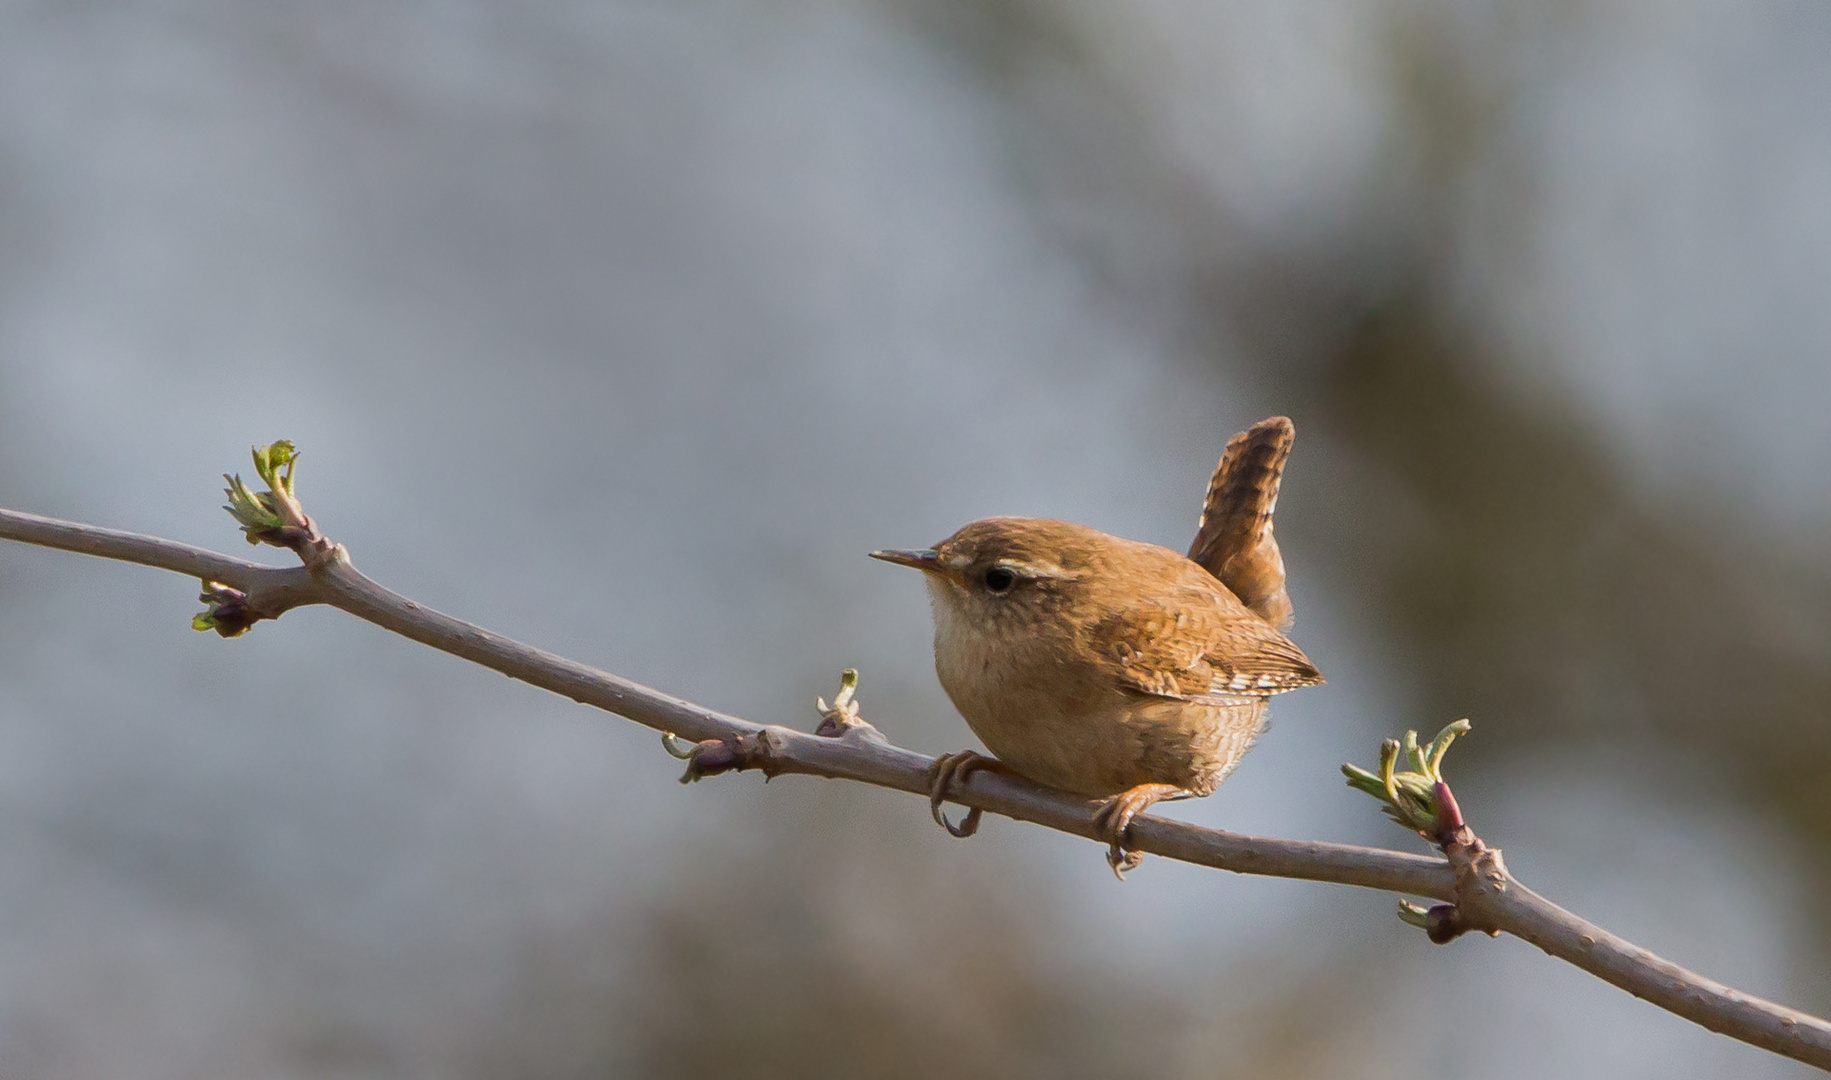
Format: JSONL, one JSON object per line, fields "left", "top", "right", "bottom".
{"left": 0, "top": 0, "right": 1831, "bottom": 1080}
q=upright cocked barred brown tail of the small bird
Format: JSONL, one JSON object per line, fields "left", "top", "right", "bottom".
{"left": 1188, "top": 416, "right": 1296, "bottom": 630}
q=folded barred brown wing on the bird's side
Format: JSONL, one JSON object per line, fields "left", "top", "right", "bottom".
{"left": 1093, "top": 600, "right": 1322, "bottom": 703}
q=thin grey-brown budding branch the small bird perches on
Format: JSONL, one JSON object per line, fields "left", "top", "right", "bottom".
{"left": 0, "top": 490, "right": 1831, "bottom": 1069}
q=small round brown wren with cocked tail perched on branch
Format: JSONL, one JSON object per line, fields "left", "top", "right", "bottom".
{"left": 872, "top": 416, "right": 1322, "bottom": 877}
